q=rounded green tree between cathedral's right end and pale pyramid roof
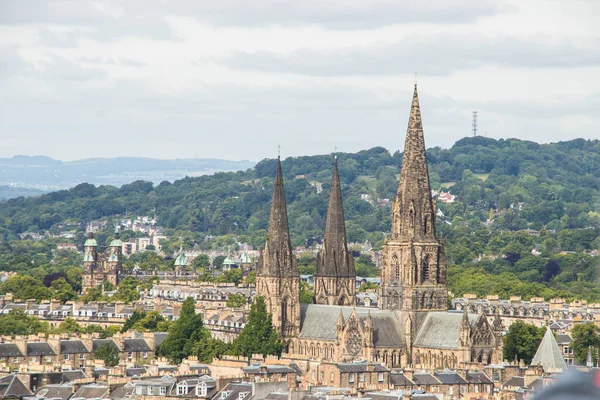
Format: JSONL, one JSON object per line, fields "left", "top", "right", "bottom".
{"left": 503, "top": 320, "right": 546, "bottom": 364}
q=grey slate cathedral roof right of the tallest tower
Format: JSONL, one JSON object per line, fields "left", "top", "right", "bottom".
{"left": 413, "top": 312, "right": 481, "bottom": 349}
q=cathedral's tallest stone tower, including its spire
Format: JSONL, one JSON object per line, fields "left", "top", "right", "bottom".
{"left": 380, "top": 84, "right": 448, "bottom": 337}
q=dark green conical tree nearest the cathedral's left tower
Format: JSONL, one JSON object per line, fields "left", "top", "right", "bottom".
{"left": 233, "top": 296, "right": 283, "bottom": 359}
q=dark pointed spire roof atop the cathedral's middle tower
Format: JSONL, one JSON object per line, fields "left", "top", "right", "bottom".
{"left": 315, "top": 158, "right": 356, "bottom": 276}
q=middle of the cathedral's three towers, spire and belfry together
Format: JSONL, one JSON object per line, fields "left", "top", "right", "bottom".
{"left": 314, "top": 157, "right": 356, "bottom": 306}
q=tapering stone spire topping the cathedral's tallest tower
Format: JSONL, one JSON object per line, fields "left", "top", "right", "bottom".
{"left": 392, "top": 84, "right": 435, "bottom": 240}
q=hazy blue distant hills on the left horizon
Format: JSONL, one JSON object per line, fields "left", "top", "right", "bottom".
{"left": 0, "top": 156, "right": 256, "bottom": 198}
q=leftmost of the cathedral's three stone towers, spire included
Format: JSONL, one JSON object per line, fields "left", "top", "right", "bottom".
{"left": 256, "top": 158, "right": 300, "bottom": 338}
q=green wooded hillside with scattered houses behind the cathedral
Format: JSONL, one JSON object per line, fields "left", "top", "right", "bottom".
{"left": 0, "top": 137, "right": 600, "bottom": 301}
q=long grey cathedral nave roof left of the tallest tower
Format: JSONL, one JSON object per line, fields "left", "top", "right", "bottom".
{"left": 298, "top": 304, "right": 404, "bottom": 347}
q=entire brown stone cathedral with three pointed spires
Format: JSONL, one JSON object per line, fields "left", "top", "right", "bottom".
{"left": 256, "top": 84, "right": 502, "bottom": 369}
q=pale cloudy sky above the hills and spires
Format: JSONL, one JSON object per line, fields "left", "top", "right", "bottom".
{"left": 0, "top": 0, "right": 600, "bottom": 160}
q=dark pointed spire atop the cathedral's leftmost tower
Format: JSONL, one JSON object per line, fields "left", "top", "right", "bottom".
{"left": 259, "top": 157, "right": 300, "bottom": 276}
